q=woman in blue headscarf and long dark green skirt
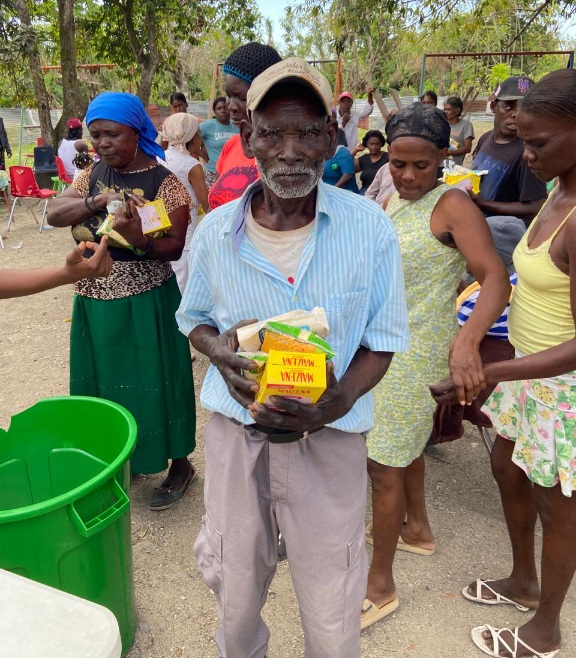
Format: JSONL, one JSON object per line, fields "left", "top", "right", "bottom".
{"left": 48, "top": 92, "right": 196, "bottom": 510}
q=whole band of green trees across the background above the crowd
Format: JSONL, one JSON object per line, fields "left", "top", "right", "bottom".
{"left": 0, "top": 0, "right": 576, "bottom": 127}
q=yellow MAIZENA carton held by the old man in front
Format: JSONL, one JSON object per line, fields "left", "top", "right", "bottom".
{"left": 256, "top": 350, "right": 326, "bottom": 404}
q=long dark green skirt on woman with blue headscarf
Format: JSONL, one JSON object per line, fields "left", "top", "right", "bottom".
{"left": 70, "top": 276, "right": 196, "bottom": 473}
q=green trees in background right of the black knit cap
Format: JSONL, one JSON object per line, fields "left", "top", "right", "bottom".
{"left": 283, "top": 0, "right": 576, "bottom": 95}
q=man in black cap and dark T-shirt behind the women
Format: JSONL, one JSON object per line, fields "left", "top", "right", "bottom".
{"left": 470, "top": 75, "right": 546, "bottom": 224}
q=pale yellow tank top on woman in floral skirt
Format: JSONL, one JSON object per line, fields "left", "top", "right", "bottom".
{"left": 509, "top": 195, "right": 576, "bottom": 354}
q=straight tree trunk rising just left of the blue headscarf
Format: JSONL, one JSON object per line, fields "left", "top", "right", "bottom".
{"left": 55, "top": 0, "right": 88, "bottom": 143}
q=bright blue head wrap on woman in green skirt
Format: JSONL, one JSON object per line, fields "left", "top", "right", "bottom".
{"left": 86, "top": 91, "right": 165, "bottom": 159}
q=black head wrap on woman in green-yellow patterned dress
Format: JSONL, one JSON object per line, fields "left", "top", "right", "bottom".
{"left": 386, "top": 103, "right": 450, "bottom": 149}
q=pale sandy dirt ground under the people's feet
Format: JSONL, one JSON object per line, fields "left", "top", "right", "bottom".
{"left": 0, "top": 190, "right": 576, "bottom": 658}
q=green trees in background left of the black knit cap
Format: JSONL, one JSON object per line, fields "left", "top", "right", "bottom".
{"left": 0, "top": 0, "right": 261, "bottom": 118}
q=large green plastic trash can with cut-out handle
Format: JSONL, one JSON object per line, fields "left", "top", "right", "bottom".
{"left": 0, "top": 397, "right": 136, "bottom": 654}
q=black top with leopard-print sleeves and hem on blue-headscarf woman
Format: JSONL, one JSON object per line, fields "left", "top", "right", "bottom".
{"left": 72, "top": 163, "right": 191, "bottom": 300}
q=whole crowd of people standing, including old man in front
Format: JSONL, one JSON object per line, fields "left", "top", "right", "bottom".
{"left": 5, "top": 38, "right": 576, "bottom": 658}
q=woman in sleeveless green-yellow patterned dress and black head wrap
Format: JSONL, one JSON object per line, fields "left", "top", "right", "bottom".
{"left": 361, "top": 103, "right": 510, "bottom": 628}
